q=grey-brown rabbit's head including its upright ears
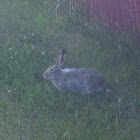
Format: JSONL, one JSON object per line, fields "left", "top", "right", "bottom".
{"left": 43, "top": 49, "right": 66, "bottom": 80}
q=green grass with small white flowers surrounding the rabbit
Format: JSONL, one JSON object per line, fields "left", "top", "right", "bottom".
{"left": 0, "top": 0, "right": 140, "bottom": 140}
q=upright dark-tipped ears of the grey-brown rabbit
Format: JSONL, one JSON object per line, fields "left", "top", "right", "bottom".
{"left": 56, "top": 49, "right": 67, "bottom": 66}
